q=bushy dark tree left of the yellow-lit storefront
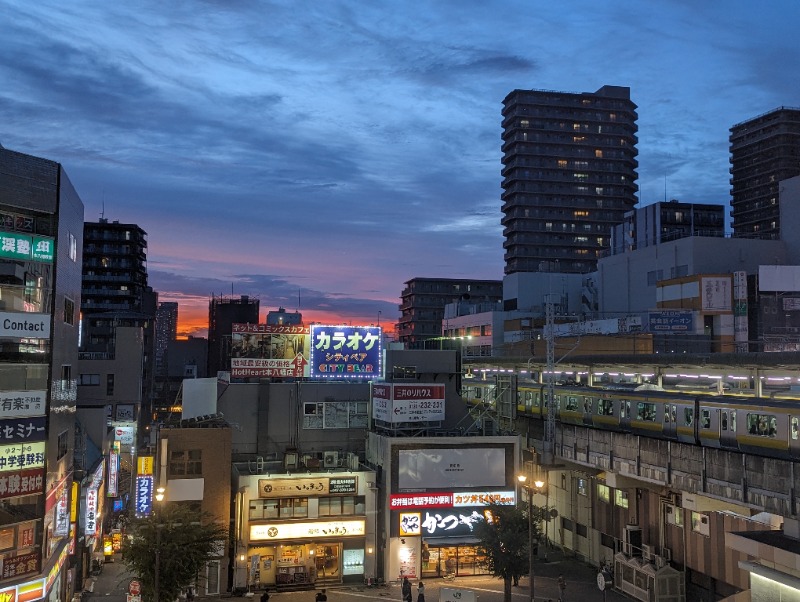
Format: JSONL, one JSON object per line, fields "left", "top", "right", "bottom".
{"left": 122, "top": 504, "right": 228, "bottom": 602}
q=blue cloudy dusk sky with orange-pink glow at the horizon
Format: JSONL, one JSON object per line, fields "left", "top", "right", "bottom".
{"left": 0, "top": 0, "right": 800, "bottom": 335}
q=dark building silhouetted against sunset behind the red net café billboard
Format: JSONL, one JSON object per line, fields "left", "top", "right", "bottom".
{"left": 207, "top": 295, "right": 259, "bottom": 376}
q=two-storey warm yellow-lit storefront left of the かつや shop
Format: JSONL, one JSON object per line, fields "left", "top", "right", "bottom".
{"left": 234, "top": 472, "right": 375, "bottom": 588}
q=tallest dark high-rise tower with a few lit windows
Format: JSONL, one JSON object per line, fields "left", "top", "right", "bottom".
{"left": 502, "top": 86, "right": 638, "bottom": 274}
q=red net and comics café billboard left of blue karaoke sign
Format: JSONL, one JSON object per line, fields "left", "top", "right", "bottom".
{"left": 231, "top": 324, "right": 310, "bottom": 378}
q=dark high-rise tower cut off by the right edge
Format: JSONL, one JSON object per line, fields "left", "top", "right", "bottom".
{"left": 730, "top": 107, "right": 800, "bottom": 240}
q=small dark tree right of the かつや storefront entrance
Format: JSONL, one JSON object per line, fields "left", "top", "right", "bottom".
{"left": 475, "top": 504, "right": 541, "bottom": 602}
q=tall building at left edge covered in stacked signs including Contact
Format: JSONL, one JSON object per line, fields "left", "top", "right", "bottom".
{"left": 0, "top": 147, "right": 84, "bottom": 601}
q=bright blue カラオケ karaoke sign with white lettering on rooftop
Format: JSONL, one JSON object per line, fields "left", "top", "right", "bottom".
{"left": 311, "top": 324, "right": 383, "bottom": 379}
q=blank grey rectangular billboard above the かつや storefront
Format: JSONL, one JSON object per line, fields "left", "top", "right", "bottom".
{"left": 398, "top": 447, "right": 506, "bottom": 491}
